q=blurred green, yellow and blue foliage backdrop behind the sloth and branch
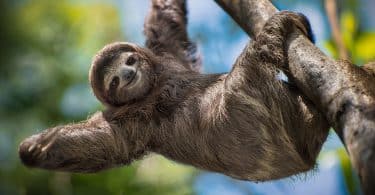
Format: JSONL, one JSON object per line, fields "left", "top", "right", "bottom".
{"left": 0, "top": 0, "right": 375, "bottom": 195}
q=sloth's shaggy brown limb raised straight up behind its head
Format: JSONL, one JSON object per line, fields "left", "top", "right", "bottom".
{"left": 144, "top": 0, "right": 201, "bottom": 71}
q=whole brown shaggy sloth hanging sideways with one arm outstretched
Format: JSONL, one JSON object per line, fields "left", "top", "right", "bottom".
{"left": 19, "top": 0, "right": 328, "bottom": 181}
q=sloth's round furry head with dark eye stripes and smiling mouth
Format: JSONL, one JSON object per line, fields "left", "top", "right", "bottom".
{"left": 90, "top": 43, "right": 154, "bottom": 106}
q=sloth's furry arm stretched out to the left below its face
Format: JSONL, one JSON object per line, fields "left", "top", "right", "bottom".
{"left": 19, "top": 112, "right": 129, "bottom": 172}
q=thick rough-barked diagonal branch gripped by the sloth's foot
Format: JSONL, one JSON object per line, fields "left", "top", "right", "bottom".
{"left": 215, "top": 0, "right": 375, "bottom": 194}
